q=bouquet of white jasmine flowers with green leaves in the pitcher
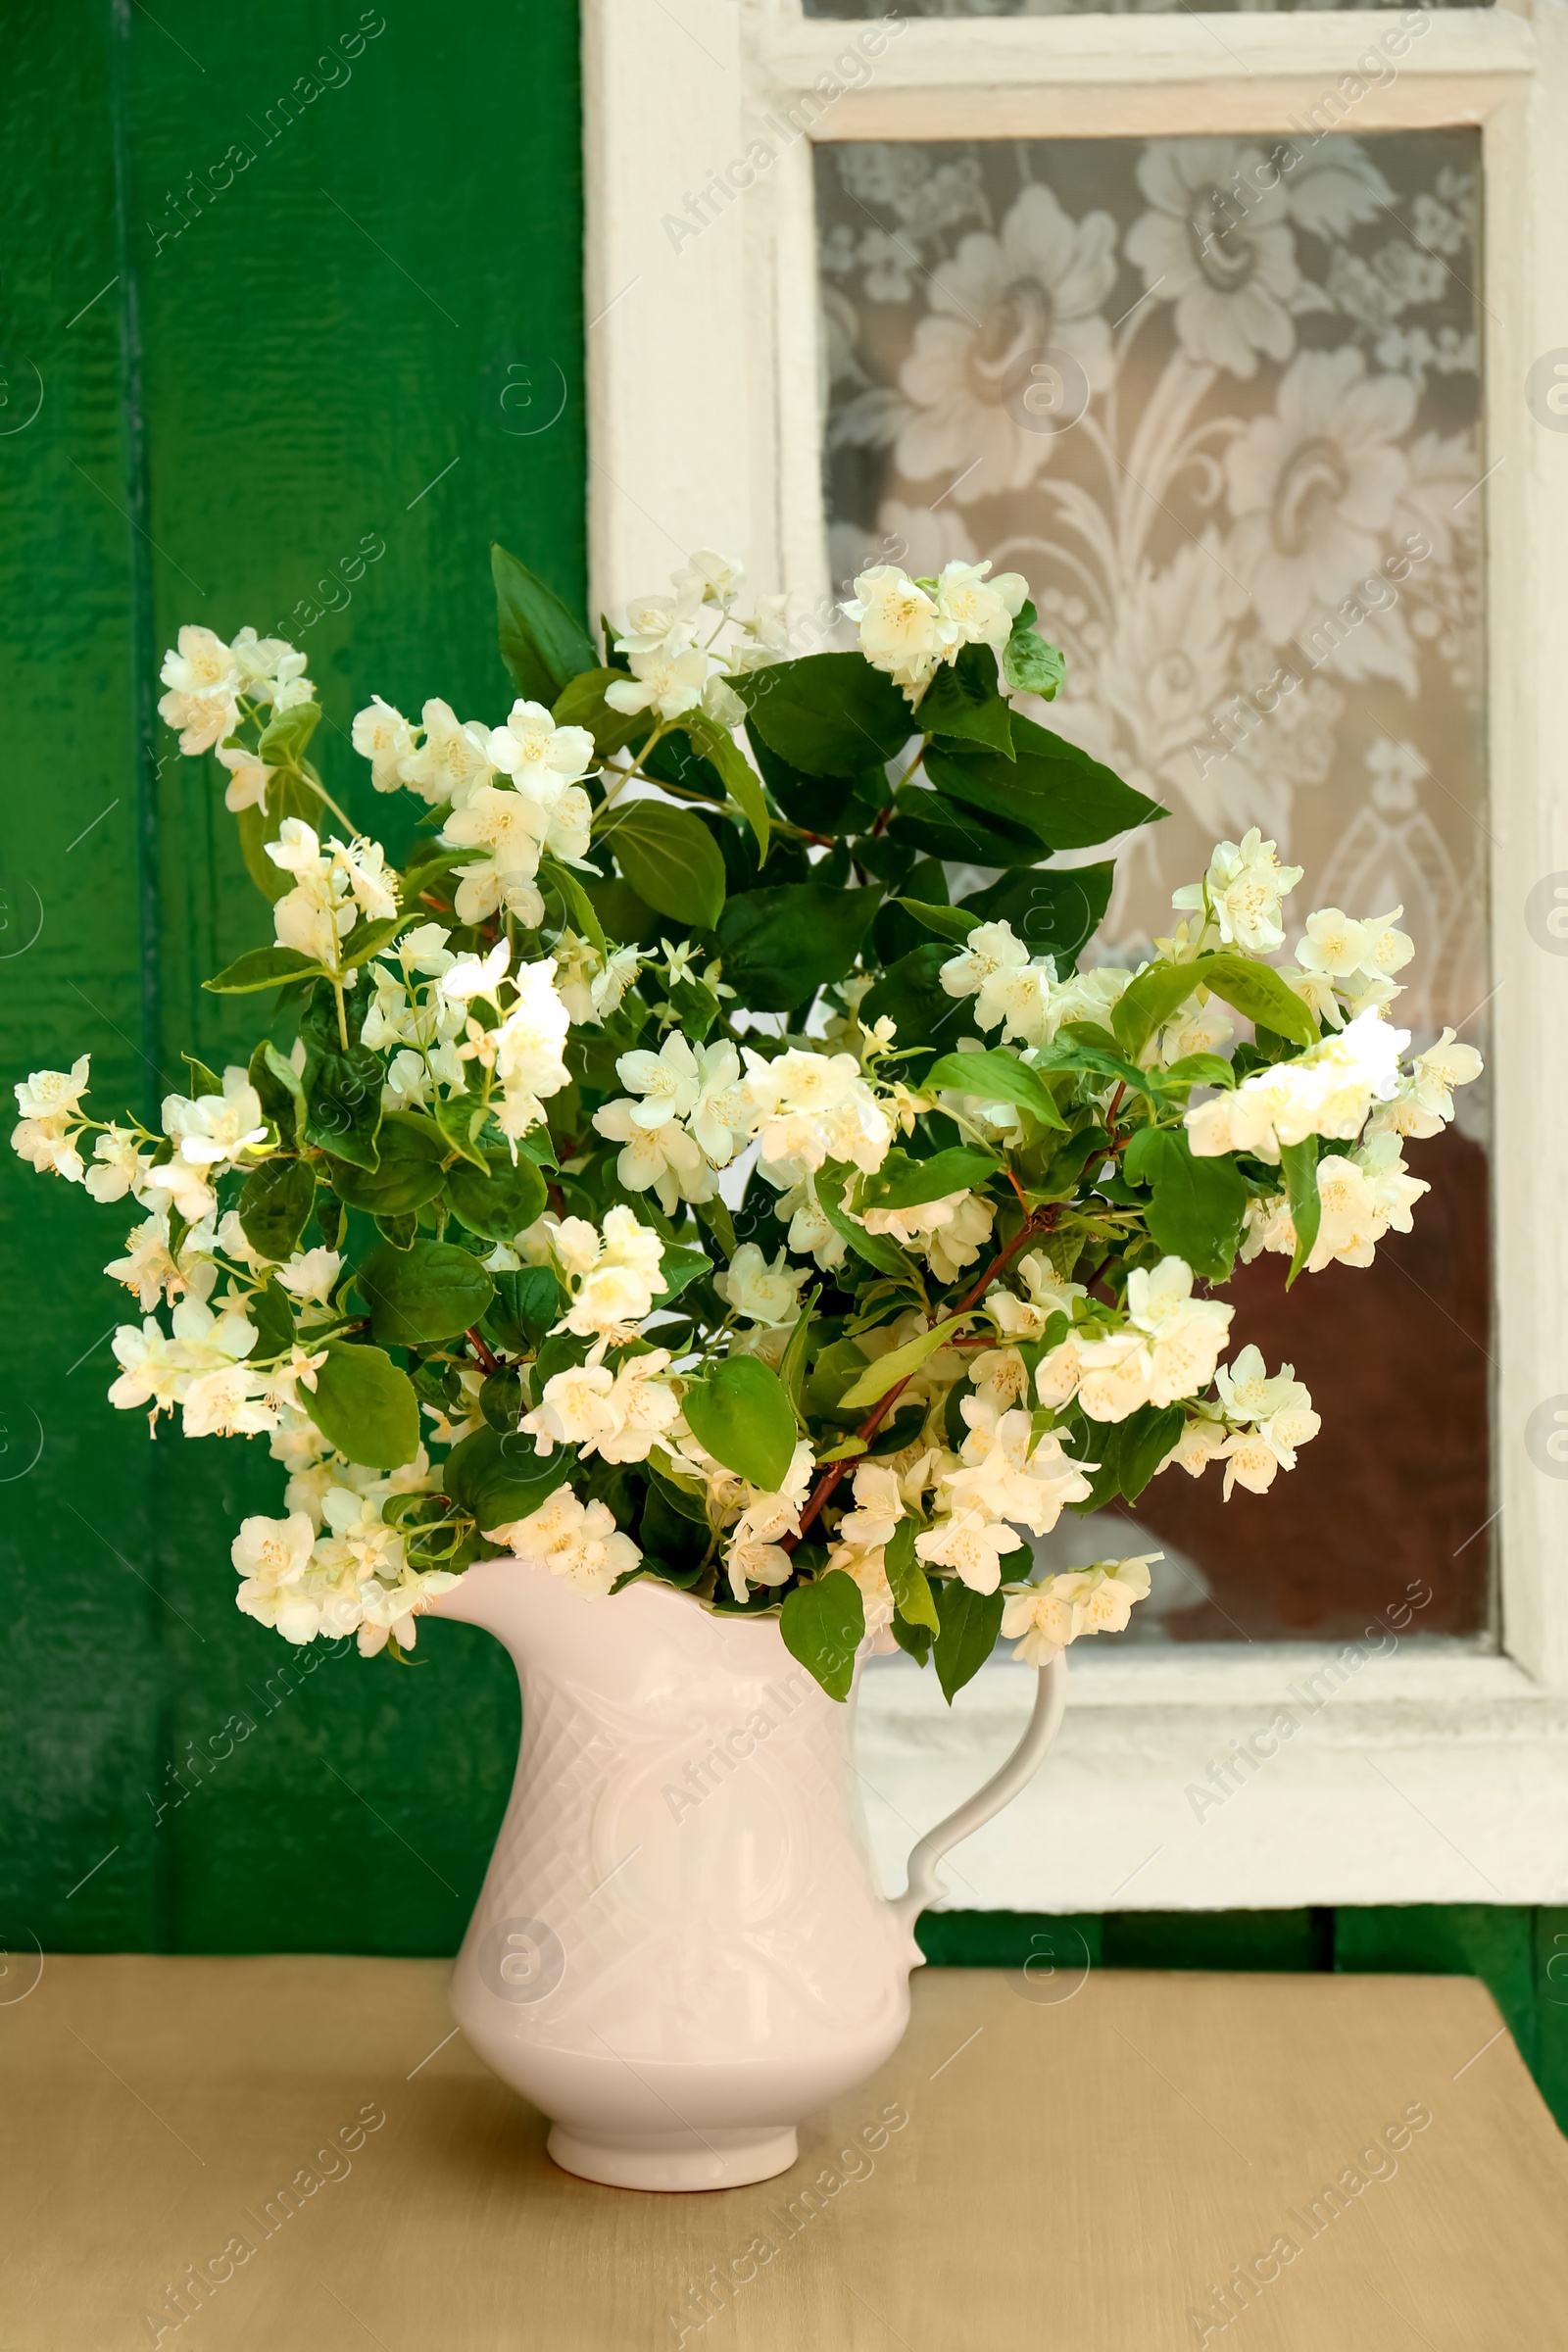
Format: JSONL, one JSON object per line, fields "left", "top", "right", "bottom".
{"left": 12, "top": 551, "right": 1481, "bottom": 1700}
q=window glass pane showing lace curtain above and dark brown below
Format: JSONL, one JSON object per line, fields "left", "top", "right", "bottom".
{"left": 815, "top": 129, "right": 1493, "bottom": 1640}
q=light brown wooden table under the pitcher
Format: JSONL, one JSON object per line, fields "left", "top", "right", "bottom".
{"left": 0, "top": 1957, "right": 1568, "bottom": 2352}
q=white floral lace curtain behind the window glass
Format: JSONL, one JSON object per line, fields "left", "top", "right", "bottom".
{"left": 815, "top": 129, "right": 1488, "bottom": 1030}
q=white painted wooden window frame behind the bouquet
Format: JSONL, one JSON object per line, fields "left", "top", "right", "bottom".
{"left": 583, "top": 0, "right": 1568, "bottom": 1912}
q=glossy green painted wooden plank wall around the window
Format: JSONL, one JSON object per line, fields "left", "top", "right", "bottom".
{"left": 0, "top": 0, "right": 1568, "bottom": 2144}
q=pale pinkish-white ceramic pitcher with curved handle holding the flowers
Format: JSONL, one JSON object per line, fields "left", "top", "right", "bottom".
{"left": 432, "top": 1559, "right": 1065, "bottom": 2189}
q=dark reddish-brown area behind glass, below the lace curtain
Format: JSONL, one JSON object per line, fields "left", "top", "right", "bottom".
{"left": 1138, "top": 1129, "right": 1493, "bottom": 1642}
